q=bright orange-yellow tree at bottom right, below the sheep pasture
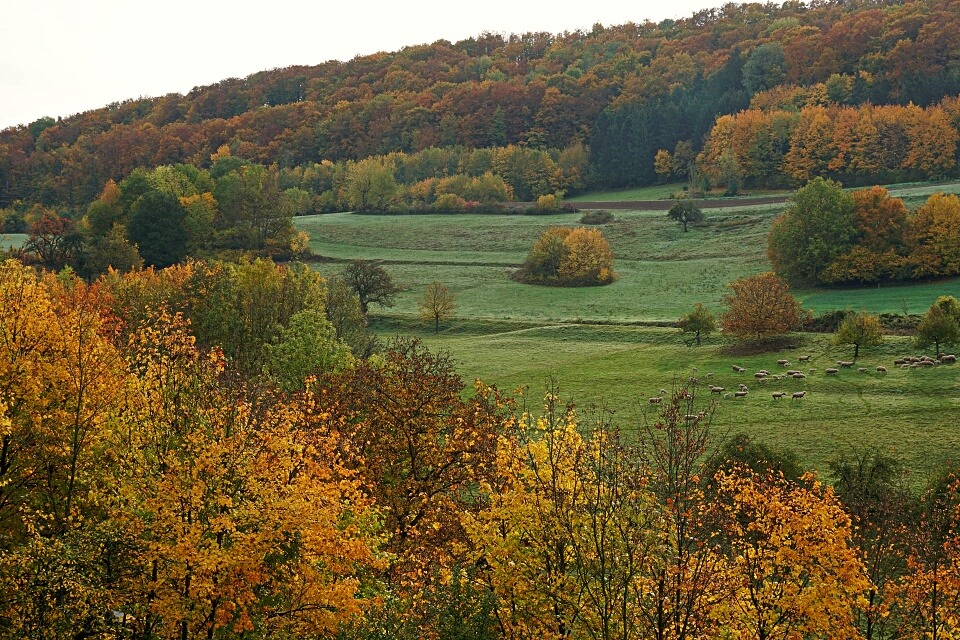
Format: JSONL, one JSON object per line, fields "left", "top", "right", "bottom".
{"left": 713, "top": 473, "right": 870, "bottom": 640}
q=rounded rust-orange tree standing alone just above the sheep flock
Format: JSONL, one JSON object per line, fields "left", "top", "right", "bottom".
{"left": 720, "top": 271, "right": 800, "bottom": 340}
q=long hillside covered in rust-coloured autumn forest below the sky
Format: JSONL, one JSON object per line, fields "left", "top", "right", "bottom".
{"left": 0, "top": 0, "right": 960, "bottom": 212}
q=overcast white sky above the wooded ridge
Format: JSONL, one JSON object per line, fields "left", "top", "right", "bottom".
{"left": 0, "top": 0, "right": 725, "bottom": 129}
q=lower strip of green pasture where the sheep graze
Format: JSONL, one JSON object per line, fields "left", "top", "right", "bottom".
{"left": 376, "top": 319, "right": 960, "bottom": 484}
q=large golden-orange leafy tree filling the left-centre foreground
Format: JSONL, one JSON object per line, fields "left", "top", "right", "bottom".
{"left": 109, "top": 312, "right": 375, "bottom": 638}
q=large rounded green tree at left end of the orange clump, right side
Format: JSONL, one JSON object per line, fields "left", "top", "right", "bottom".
{"left": 767, "top": 178, "right": 857, "bottom": 283}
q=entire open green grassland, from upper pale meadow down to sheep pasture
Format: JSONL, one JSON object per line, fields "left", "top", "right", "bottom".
{"left": 297, "top": 185, "right": 960, "bottom": 483}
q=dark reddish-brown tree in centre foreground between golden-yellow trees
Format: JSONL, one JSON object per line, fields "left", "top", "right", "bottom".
{"left": 322, "top": 342, "right": 508, "bottom": 589}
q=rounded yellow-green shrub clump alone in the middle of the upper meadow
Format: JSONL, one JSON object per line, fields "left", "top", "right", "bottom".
{"left": 517, "top": 227, "right": 616, "bottom": 287}
